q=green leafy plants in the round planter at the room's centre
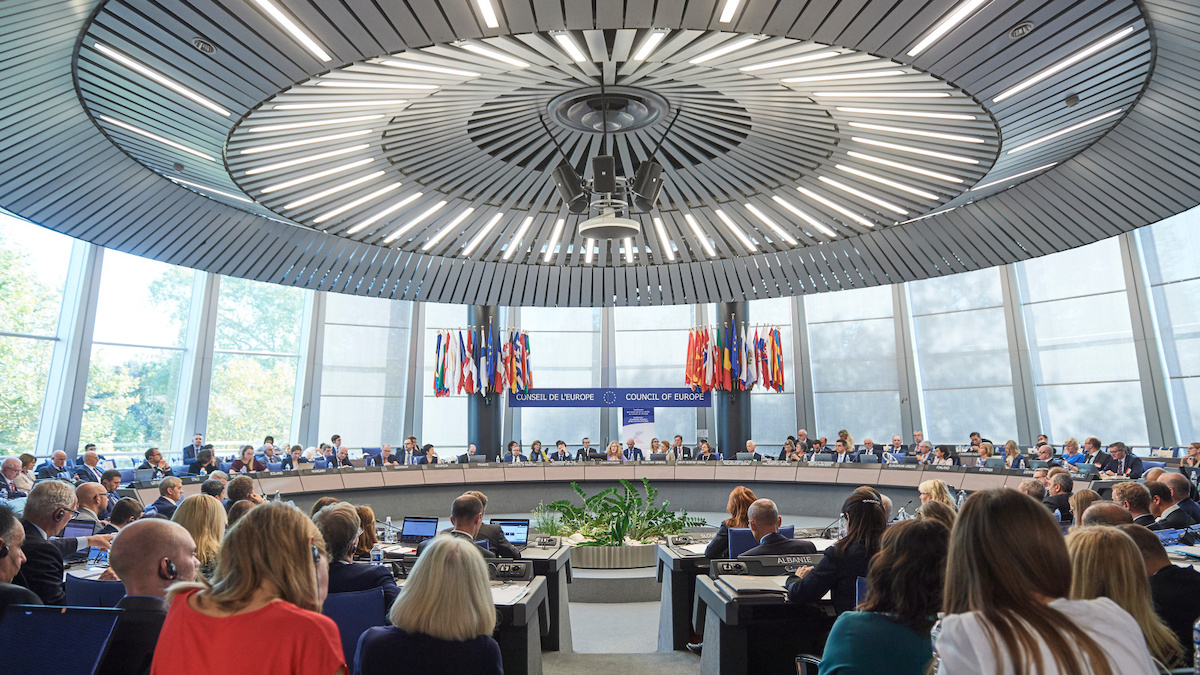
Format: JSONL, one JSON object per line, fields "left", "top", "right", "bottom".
{"left": 534, "top": 478, "right": 706, "bottom": 546}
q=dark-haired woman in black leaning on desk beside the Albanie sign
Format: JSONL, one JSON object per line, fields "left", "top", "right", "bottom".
{"left": 787, "top": 488, "right": 888, "bottom": 614}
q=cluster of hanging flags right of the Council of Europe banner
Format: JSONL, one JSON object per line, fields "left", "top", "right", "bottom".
{"left": 684, "top": 323, "right": 784, "bottom": 392}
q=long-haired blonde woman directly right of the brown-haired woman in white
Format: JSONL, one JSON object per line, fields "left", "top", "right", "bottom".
{"left": 1067, "top": 527, "right": 1183, "bottom": 668}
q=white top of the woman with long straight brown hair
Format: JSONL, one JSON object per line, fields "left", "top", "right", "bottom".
{"left": 934, "top": 598, "right": 1158, "bottom": 675}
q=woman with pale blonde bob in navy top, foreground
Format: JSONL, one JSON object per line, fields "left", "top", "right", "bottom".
{"left": 354, "top": 536, "right": 504, "bottom": 675}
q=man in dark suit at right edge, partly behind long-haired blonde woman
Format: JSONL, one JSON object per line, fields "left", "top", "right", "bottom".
{"left": 1120, "top": 525, "right": 1200, "bottom": 663}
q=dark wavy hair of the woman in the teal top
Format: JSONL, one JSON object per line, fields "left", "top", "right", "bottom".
{"left": 858, "top": 520, "right": 950, "bottom": 635}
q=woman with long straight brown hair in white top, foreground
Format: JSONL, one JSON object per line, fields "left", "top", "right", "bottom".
{"left": 934, "top": 488, "right": 1157, "bottom": 675}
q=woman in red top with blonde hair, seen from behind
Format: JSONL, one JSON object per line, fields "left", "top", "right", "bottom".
{"left": 150, "top": 502, "right": 347, "bottom": 675}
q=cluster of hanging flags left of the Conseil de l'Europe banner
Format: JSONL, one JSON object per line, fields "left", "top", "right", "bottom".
{"left": 433, "top": 325, "right": 533, "bottom": 396}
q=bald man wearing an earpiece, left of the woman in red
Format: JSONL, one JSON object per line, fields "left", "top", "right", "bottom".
{"left": 95, "top": 518, "right": 199, "bottom": 675}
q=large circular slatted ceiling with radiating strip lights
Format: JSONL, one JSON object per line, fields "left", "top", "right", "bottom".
{"left": 0, "top": 0, "right": 1200, "bottom": 305}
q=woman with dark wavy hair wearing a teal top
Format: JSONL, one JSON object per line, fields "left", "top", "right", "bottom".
{"left": 821, "top": 520, "right": 950, "bottom": 675}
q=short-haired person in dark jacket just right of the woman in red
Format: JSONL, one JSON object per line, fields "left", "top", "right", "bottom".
{"left": 312, "top": 502, "right": 400, "bottom": 607}
